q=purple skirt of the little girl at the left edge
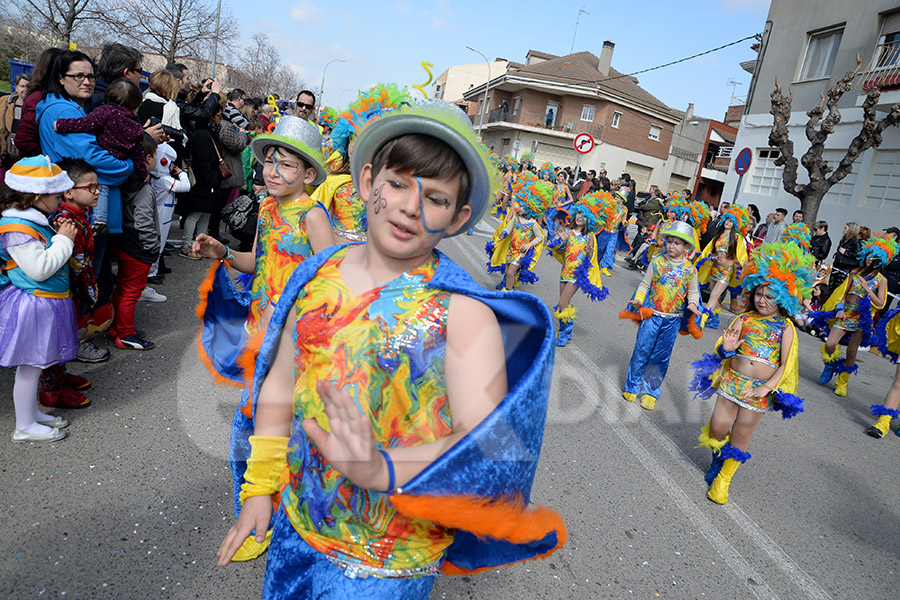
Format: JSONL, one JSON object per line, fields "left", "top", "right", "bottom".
{"left": 0, "top": 285, "right": 78, "bottom": 368}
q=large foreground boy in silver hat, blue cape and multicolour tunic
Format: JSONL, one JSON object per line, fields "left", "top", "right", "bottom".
{"left": 218, "top": 101, "right": 564, "bottom": 600}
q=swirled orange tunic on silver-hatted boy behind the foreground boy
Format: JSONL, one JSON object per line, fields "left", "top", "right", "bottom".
{"left": 247, "top": 196, "right": 324, "bottom": 334}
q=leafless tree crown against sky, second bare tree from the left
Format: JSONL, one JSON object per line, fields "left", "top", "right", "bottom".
{"left": 96, "top": 0, "right": 240, "bottom": 62}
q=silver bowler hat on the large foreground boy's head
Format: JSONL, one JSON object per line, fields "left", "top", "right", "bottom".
{"left": 350, "top": 100, "right": 491, "bottom": 235}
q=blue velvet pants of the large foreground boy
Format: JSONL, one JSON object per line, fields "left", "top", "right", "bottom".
{"left": 262, "top": 507, "right": 435, "bottom": 600}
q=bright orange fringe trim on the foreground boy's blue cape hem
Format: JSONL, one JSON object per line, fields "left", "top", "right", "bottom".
{"left": 390, "top": 494, "right": 568, "bottom": 575}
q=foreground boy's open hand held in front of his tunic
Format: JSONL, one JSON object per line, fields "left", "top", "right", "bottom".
{"left": 303, "top": 381, "right": 388, "bottom": 490}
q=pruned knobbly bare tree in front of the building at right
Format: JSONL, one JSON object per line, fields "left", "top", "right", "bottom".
{"left": 769, "top": 56, "right": 900, "bottom": 229}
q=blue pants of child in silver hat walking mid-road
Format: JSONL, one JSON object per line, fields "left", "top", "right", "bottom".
{"left": 625, "top": 315, "right": 681, "bottom": 398}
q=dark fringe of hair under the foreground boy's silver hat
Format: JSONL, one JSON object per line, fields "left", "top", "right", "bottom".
{"left": 372, "top": 133, "right": 469, "bottom": 217}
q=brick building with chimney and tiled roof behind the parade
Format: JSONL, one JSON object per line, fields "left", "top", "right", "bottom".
{"left": 463, "top": 41, "right": 680, "bottom": 190}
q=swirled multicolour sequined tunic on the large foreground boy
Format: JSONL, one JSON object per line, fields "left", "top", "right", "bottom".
{"left": 282, "top": 249, "right": 454, "bottom": 571}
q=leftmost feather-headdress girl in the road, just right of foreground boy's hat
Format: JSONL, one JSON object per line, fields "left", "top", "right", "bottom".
{"left": 485, "top": 173, "right": 553, "bottom": 290}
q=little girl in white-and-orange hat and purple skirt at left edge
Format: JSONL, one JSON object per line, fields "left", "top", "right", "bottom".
{"left": 0, "top": 156, "right": 78, "bottom": 442}
